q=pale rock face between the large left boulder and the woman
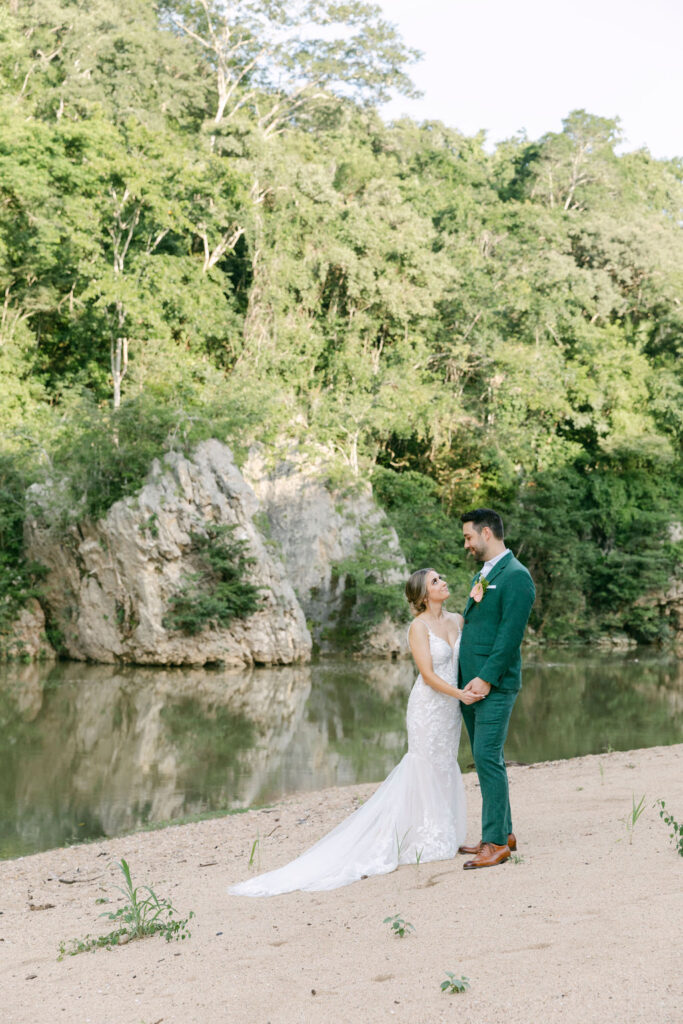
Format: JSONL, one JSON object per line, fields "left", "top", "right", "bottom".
{"left": 243, "top": 447, "right": 408, "bottom": 656}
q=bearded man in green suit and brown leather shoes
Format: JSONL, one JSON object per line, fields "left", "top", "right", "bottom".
{"left": 459, "top": 509, "right": 536, "bottom": 869}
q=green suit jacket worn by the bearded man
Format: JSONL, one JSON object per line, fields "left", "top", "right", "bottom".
{"left": 459, "top": 552, "right": 536, "bottom": 692}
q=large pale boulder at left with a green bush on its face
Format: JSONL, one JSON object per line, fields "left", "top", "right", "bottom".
{"left": 27, "top": 440, "right": 311, "bottom": 666}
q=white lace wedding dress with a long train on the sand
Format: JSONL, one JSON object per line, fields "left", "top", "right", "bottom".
{"left": 229, "top": 631, "right": 467, "bottom": 896}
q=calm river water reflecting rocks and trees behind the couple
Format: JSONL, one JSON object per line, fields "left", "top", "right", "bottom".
{"left": 0, "top": 647, "right": 683, "bottom": 858}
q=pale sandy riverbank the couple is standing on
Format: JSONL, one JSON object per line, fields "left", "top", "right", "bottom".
{"left": 0, "top": 744, "right": 683, "bottom": 1024}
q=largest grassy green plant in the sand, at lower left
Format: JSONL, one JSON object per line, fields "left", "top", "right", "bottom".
{"left": 57, "top": 858, "right": 195, "bottom": 959}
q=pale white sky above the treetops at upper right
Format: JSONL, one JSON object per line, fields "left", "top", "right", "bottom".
{"left": 375, "top": 0, "right": 683, "bottom": 158}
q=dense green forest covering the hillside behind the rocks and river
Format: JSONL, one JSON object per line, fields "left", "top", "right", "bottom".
{"left": 0, "top": 0, "right": 683, "bottom": 640}
